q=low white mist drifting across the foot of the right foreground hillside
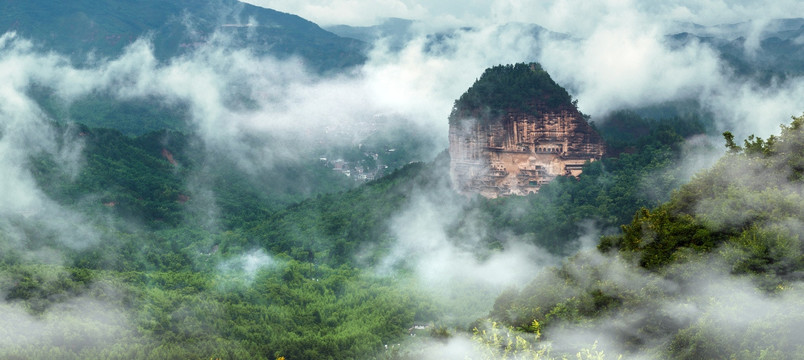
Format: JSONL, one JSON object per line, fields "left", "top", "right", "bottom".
{"left": 408, "top": 250, "right": 802, "bottom": 359}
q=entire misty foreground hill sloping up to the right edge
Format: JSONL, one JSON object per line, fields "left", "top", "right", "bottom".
{"left": 490, "top": 115, "right": 804, "bottom": 359}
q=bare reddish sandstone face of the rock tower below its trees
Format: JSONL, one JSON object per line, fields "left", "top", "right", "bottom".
{"left": 449, "top": 103, "right": 605, "bottom": 198}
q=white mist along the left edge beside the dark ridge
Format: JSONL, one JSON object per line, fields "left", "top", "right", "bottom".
{"left": 0, "top": 33, "right": 98, "bottom": 253}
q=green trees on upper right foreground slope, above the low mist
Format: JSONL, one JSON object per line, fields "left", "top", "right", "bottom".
{"left": 600, "top": 116, "right": 804, "bottom": 274}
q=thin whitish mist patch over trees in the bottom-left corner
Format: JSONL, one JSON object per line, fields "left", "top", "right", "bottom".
{"left": 0, "top": 267, "right": 136, "bottom": 358}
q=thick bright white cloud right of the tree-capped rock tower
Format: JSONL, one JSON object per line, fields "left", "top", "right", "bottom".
{"left": 502, "top": 1, "right": 804, "bottom": 141}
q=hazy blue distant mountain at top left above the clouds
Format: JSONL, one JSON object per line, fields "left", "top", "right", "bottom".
{"left": 0, "top": 0, "right": 365, "bottom": 71}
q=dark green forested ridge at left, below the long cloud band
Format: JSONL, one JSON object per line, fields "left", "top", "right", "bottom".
{"left": 30, "top": 124, "right": 355, "bottom": 228}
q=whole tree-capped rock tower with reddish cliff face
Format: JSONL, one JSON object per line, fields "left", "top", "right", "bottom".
{"left": 449, "top": 64, "right": 605, "bottom": 198}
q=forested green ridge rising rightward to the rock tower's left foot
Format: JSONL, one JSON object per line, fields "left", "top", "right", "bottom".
{"left": 246, "top": 156, "right": 457, "bottom": 264}
